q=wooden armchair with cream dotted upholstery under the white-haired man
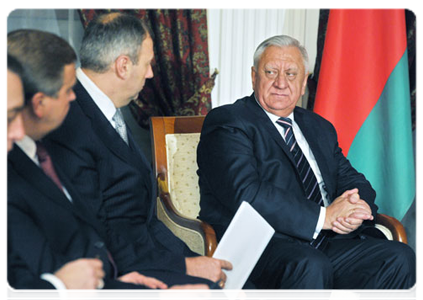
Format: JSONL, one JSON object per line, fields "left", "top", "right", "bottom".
{"left": 150, "top": 116, "right": 407, "bottom": 300}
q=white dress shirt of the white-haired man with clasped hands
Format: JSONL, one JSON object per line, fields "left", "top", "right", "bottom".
{"left": 256, "top": 99, "right": 329, "bottom": 238}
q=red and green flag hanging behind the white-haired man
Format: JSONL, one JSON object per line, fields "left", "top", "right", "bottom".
{"left": 314, "top": 9, "right": 415, "bottom": 220}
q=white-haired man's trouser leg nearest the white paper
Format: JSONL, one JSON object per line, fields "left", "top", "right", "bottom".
{"left": 250, "top": 238, "right": 333, "bottom": 300}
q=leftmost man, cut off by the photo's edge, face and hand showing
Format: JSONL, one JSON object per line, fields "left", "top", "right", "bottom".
{"left": 5, "top": 53, "right": 104, "bottom": 300}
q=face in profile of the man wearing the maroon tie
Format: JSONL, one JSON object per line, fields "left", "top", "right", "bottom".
{"left": 43, "top": 64, "right": 76, "bottom": 132}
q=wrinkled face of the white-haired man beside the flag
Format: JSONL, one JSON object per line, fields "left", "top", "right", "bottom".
{"left": 251, "top": 46, "right": 308, "bottom": 117}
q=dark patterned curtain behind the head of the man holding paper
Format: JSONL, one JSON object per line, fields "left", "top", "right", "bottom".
{"left": 80, "top": 8, "right": 216, "bottom": 128}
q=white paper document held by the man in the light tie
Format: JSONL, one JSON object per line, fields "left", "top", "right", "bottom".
{"left": 213, "top": 201, "right": 275, "bottom": 300}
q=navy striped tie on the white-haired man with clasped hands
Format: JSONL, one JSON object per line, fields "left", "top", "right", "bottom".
{"left": 276, "top": 117, "right": 325, "bottom": 248}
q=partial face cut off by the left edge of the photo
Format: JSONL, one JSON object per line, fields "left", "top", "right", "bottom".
{"left": 4, "top": 69, "right": 25, "bottom": 154}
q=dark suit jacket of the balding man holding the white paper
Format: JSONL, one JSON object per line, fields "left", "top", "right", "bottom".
{"left": 46, "top": 82, "right": 196, "bottom": 272}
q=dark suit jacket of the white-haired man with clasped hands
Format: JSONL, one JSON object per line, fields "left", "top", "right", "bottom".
{"left": 197, "top": 95, "right": 377, "bottom": 241}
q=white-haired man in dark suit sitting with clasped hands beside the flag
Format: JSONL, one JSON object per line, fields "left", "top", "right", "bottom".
{"left": 197, "top": 36, "right": 418, "bottom": 300}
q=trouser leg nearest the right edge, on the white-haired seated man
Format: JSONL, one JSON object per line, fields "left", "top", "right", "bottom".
{"left": 323, "top": 238, "right": 418, "bottom": 300}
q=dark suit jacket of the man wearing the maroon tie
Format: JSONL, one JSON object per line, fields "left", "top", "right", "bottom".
{"left": 6, "top": 147, "right": 162, "bottom": 299}
